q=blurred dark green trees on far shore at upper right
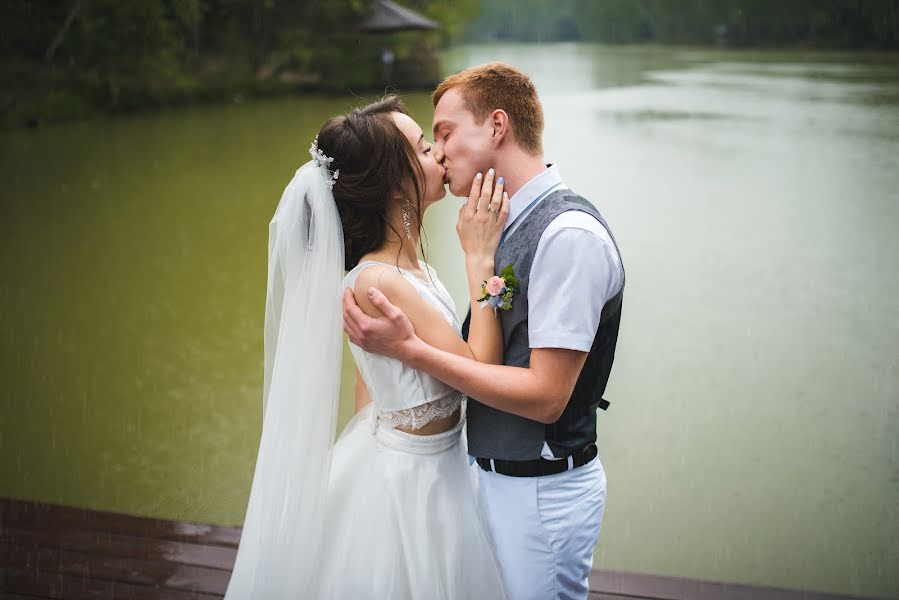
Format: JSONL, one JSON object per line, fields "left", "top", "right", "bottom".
{"left": 468, "top": 0, "right": 899, "bottom": 49}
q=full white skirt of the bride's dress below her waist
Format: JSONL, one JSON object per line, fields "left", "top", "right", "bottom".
{"left": 306, "top": 404, "right": 505, "bottom": 600}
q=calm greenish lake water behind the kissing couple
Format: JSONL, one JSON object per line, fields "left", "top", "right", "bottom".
{"left": 0, "top": 44, "right": 899, "bottom": 597}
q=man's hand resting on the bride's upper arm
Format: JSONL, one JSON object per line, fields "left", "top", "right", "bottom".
{"left": 343, "top": 288, "right": 420, "bottom": 360}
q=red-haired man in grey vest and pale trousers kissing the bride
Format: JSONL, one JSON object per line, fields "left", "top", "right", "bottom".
{"left": 344, "top": 63, "right": 624, "bottom": 600}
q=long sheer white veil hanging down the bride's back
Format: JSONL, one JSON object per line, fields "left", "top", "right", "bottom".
{"left": 225, "top": 160, "right": 344, "bottom": 600}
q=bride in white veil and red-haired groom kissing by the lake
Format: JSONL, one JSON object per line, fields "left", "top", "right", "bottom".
{"left": 226, "top": 62, "right": 624, "bottom": 600}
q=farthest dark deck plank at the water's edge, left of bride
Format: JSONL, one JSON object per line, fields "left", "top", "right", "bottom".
{"left": 0, "top": 498, "right": 241, "bottom": 548}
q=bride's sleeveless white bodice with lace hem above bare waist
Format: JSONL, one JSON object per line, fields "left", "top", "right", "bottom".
{"left": 344, "top": 261, "right": 464, "bottom": 429}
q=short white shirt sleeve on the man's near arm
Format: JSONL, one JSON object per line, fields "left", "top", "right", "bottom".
{"left": 528, "top": 211, "right": 623, "bottom": 352}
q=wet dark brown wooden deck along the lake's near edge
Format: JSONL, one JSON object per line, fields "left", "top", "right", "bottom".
{"left": 0, "top": 498, "right": 872, "bottom": 600}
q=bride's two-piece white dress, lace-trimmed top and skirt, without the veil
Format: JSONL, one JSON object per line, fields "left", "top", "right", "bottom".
{"left": 308, "top": 261, "right": 505, "bottom": 600}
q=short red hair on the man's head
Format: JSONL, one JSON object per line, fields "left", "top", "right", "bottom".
{"left": 431, "top": 62, "right": 543, "bottom": 154}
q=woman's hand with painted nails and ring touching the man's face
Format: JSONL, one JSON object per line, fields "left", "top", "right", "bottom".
{"left": 456, "top": 169, "right": 509, "bottom": 262}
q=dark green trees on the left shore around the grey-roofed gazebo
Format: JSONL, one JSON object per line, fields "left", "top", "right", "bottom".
{"left": 0, "top": 0, "right": 464, "bottom": 124}
